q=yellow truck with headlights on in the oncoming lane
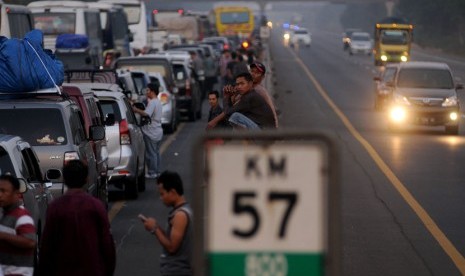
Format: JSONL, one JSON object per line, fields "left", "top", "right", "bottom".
{"left": 373, "top": 18, "right": 413, "bottom": 66}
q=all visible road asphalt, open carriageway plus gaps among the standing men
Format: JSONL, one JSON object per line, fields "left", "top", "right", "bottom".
{"left": 112, "top": 3, "right": 465, "bottom": 275}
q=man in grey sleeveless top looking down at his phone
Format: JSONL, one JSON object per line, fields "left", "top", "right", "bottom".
{"left": 141, "top": 171, "right": 194, "bottom": 276}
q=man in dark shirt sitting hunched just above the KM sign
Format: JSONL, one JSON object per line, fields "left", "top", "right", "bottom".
{"left": 207, "top": 73, "right": 276, "bottom": 129}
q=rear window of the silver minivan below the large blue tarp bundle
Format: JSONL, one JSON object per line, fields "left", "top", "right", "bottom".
{"left": 0, "top": 108, "right": 67, "bottom": 146}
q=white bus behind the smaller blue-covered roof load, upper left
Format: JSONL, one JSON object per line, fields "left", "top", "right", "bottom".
{"left": 28, "top": 1, "right": 103, "bottom": 64}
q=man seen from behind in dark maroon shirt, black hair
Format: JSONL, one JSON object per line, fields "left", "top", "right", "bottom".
{"left": 39, "top": 160, "right": 116, "bottom": 276}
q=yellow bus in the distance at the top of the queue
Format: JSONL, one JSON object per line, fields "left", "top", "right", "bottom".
{"left": 213, "top": 6, "right": 254, "bottom": 38}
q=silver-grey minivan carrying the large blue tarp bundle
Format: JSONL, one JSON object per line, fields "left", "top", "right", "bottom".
{"left": 0, "top": 92, "right": 106, "bottom": 202}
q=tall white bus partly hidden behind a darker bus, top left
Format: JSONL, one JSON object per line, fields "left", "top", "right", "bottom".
{"left": 99, "top": 0, "right": 149, "bottom": 55}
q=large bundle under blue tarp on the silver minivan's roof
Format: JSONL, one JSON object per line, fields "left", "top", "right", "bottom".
{"left": 0, "top": 30, "right": 64, "bottom": 93}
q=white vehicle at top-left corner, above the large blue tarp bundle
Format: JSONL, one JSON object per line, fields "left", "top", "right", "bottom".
{"left": 0, "top": 1, "right": 33, "bottom": 38}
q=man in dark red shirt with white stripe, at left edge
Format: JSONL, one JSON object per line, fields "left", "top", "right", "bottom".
{"left": 0, "top": 175, "right": 36, "bottom": 276}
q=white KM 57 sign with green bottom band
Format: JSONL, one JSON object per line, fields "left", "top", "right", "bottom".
{"left": 192, "top": 132, "right": 339, "bottom": 276}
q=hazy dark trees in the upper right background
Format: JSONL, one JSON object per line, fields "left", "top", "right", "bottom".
{"left": 341, "top": 0, "right": 465, "bottom": 55}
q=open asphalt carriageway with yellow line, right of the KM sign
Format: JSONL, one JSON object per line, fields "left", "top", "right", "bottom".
{"left": 272, "top": 14, "right": 465, "bottom": 275}
